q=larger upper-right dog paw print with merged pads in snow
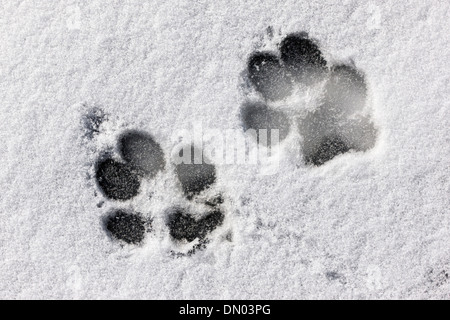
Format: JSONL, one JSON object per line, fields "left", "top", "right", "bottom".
{"left": 240, "top": 33, "right": 377, "bottom": 166}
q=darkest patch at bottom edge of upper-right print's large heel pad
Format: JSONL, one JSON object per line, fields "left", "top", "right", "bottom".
{"left": 305, "top": 136, "right": 350, "bottom": 166}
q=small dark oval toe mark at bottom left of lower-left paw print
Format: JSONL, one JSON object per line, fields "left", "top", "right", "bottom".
{"left": 104, "top": 210, "right": 146, "bottom": 244}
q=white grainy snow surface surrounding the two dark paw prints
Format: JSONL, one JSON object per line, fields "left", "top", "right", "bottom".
{"left": 0, "top": 0, "right": 450, "bottom": 299}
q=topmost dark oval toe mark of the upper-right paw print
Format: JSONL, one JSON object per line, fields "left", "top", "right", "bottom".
{"left": 280, "top": 33, "right": 327, "bottom": 82}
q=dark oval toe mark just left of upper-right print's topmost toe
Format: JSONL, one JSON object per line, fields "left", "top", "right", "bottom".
{"left": 248, "top": 52, "right": 292, "bottom": 100}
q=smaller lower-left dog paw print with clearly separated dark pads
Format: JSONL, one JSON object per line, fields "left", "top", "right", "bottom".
{"left": 95, "top": 131, "right": 225, "bottom": 254}
